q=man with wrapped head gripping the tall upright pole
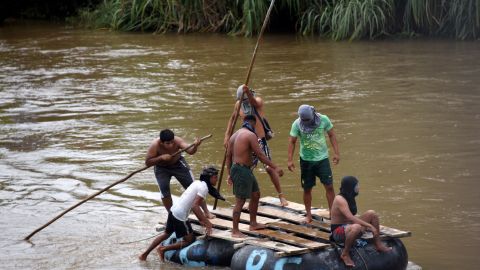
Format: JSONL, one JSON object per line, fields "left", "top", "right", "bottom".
{"left": 224, "top": 85, "right": 288, "bottom": 206}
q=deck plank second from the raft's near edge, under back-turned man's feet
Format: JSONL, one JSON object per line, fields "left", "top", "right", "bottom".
{"left": 189, "top": 215, "right": 330, "bottom": 249}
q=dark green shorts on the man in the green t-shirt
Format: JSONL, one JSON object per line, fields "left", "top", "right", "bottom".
{"left": 300, "top": 158, "right": 333, "bottom": 189}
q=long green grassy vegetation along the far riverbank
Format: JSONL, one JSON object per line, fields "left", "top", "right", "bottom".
{"left": 8, "top": 0, "right": 480, "bottom": 40}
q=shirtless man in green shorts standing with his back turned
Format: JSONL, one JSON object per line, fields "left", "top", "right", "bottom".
{"left": 226, "top": 115, "right": 283, "bottom": 238}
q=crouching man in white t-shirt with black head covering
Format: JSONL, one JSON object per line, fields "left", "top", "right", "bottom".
{"left": 139, "top": 166, "right": 225, "bottom": 261}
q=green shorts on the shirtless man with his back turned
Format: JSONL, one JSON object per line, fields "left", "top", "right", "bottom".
{"left": 230, "top": 163, "right": 260, "bottom": 199}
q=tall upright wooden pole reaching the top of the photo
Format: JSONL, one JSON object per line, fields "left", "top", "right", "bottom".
{"left": 213, "top": 0, "right": 275, "bottom": 210}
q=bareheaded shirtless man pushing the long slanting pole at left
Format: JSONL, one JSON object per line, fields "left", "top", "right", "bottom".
{"left": 145, "top": 129, "right": 215, "bottom": 219}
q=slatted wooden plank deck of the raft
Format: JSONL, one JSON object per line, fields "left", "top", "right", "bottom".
{"left": 156, "top": 197, "right": 411, "bottom": 256}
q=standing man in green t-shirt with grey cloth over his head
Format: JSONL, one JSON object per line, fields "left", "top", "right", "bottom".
{"left": 288, "top": 105, "right": 340, "bottom": 223}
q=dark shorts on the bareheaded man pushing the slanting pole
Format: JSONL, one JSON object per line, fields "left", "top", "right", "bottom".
{"left": 154, "top": 157, "right": 194, "bottom": 199}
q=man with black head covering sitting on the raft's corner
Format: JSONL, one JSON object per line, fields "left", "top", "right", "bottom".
{"left": 330, "top": 176, "right": 391, "bottom": 267}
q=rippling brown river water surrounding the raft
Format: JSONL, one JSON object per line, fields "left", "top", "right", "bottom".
{"left": 0, "top": 22, "right": 480, "bottom": 269}
